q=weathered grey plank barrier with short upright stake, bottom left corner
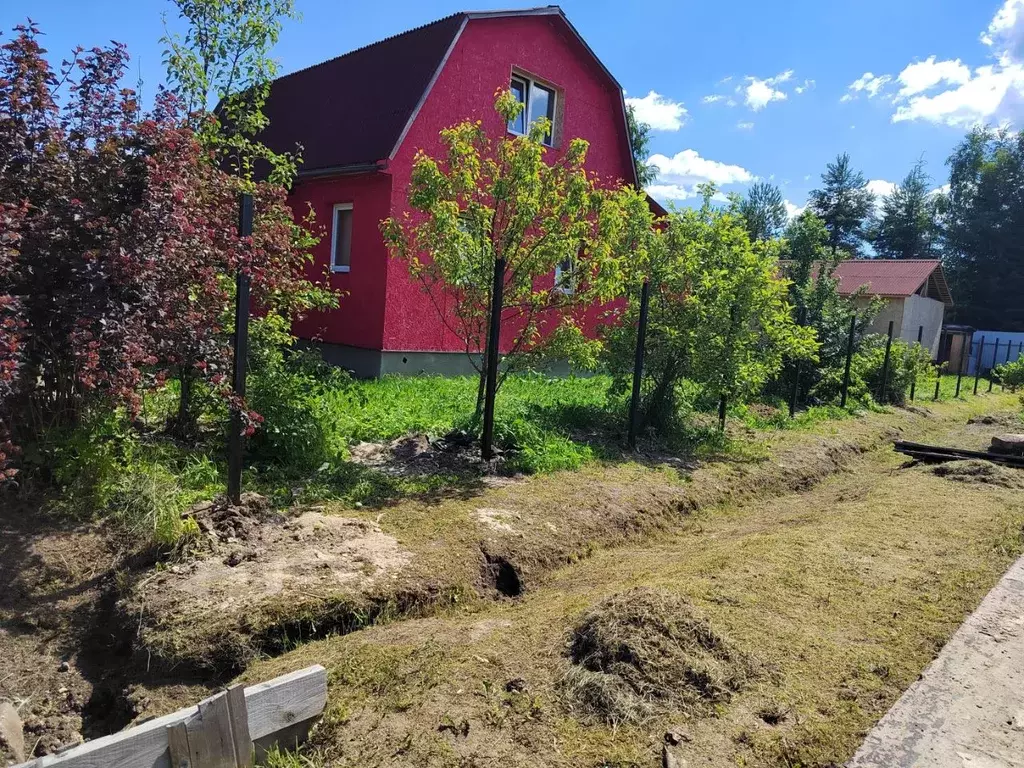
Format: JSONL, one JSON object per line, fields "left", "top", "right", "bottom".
{"left": 15, "top": 665, "right": 327, "bottom": 768}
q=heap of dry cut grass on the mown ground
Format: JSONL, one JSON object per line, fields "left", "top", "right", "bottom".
{"left": 562, "top": 588, "right": 759, "bottom": 725}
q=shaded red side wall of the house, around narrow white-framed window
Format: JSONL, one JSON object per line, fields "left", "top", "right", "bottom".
{"left": 290, "top": 173, "right": 391, "bottom": 349}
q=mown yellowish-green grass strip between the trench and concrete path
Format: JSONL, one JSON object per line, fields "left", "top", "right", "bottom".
{"left": 232, "top": 394, "right": 1024, "bottom": 768}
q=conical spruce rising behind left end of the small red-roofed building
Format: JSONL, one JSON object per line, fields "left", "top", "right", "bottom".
{"left": 809, "top": 153, "right": 874, "bottom": 256}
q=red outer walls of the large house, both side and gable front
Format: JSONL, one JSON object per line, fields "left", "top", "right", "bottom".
{"left": 292, "top": 16, "right": 633, "bottom": 352}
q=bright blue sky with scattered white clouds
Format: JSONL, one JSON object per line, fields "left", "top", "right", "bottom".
{"left": 8, "top": 0, "right": 1024, "bottom": 210}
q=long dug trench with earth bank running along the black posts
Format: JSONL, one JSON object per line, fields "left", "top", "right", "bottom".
{"left": 0, "top": 397, "right": 1015, "bottom": 764}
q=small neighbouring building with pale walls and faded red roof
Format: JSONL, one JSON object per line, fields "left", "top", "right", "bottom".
{"left": 835, "top": 259, "right": 953, "bottom": 358}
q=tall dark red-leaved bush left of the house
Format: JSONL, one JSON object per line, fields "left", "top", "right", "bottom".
{"left": 0, "top": 26, "right": 330, "bottom": 473}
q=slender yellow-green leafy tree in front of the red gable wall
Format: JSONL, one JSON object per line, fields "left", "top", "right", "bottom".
{"left": 381, "top": 91, "right": 626, "bottom": 421}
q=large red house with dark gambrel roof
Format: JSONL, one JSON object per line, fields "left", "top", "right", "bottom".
{"left": 263, "top": 6, "right": 636, "bottom": 376}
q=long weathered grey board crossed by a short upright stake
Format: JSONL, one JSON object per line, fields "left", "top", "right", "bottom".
{"left": 15, "top": 665, "right": 327, "bottom": 768}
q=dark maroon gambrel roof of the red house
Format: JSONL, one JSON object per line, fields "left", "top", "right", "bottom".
{"left": 260, "top": 5, "right": 636, "bottom": 186}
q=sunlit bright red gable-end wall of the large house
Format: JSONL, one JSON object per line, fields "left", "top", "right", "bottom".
{"left": 384, "top": 16, "right": 633, "bottom": 351}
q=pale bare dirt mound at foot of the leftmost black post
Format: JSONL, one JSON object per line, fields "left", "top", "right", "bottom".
{"left": 126, "top": 507, "right": 410, "bottom": 672}
